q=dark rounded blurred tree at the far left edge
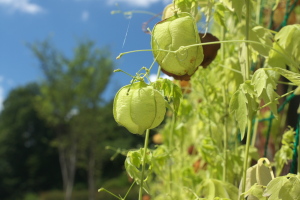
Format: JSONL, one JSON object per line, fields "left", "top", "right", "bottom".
{"left": 0, "top": 83, "right": 61, "bottom": 199}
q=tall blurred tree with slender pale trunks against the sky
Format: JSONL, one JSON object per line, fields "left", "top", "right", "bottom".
{"left": 30, "top": 40, "right": 114, "bottom": 200}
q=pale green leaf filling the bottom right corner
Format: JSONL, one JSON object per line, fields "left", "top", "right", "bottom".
{"left": 263, "top": 174, "right": 300, "bottom": 200}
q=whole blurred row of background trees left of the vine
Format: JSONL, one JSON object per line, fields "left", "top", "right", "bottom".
{"left": 0, "top": 40, "right": 142, "bottom": 200}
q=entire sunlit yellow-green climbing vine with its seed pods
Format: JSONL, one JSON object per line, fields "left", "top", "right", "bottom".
{"left": 99, "top": 0, "right": 300, "bottom": 200}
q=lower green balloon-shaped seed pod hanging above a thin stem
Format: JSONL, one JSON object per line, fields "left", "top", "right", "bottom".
{"left": 113, "top": 82, "right": 166, "bottom": 134}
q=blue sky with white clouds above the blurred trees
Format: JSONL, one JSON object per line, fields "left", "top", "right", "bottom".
{"left": 0, "top": 0, "right": 171, "bottom": 110}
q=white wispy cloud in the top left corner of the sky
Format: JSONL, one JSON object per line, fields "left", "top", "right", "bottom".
{"left": 0, "top": 0, "right": 43, "bottom": 14}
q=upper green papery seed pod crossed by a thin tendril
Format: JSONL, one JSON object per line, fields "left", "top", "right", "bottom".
{"left": 151, "top": 13, "right": 204, "bottom": 76}
